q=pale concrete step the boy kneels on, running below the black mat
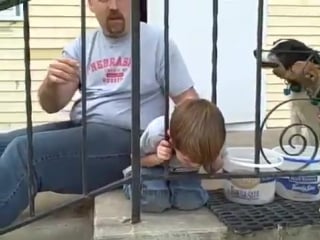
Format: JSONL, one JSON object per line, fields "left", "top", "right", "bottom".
{"left": 93, "top": 190, "right": 320, "bottom": 240}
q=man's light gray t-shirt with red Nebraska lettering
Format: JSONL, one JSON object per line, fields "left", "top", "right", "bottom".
{"left": 63, "top": 23, "right": 193, "bottom": 129}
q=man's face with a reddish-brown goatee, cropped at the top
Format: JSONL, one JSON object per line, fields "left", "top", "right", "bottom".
{"left": 88, "top": 0, "right": 131, "bottom": 37}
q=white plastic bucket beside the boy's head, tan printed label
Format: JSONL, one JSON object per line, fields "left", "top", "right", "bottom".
{"left": 223, "top": 147, "right": 283, "bottom": 205}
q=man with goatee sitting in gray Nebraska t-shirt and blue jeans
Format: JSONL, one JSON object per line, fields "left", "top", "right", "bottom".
{"left": 0, "top": 0, "right": 198, "bottom": 228}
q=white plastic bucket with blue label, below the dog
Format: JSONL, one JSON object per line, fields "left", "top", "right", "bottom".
{"left": 273, "top": 145, "right": 320, "bottom": 202}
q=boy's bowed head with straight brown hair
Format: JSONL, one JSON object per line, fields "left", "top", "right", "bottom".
{"left": 169, "top": 99, "right": 226, "bottom": 172}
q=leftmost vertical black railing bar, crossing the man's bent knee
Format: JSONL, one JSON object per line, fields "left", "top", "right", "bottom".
{"left": 23, "top": 1, "right": 35, "bottom": 217}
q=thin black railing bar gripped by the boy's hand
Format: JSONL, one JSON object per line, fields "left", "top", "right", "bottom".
{"left": 164, "top": 0, "right": 170, "bottom": 175}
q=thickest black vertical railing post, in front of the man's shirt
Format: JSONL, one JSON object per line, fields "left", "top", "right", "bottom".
{"left": 131, "top": 0, "right": 141, "bottom": 224}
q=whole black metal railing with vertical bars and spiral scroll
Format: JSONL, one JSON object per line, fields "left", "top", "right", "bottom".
{"left": 0, "top": 0, "right": 320, "bottom": 235}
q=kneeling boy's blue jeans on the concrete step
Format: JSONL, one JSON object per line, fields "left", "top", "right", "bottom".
{"left": 123, "top": 167, "right": 208, "bottom": 213}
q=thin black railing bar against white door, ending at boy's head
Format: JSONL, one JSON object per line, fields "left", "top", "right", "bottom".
{"left": 211, "top": 0, "right": 219, "bottom": 103}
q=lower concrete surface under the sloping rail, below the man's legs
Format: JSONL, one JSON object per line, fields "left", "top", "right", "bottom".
{"left": 0, "top": 193, "right": 93, "bottom": 240}
